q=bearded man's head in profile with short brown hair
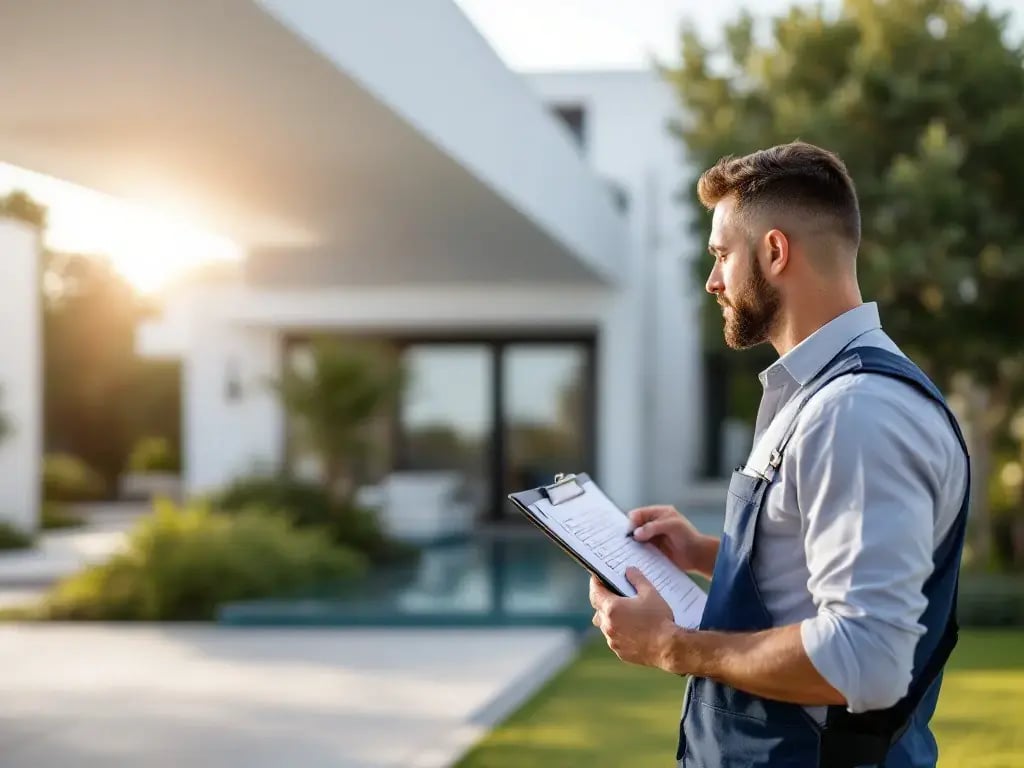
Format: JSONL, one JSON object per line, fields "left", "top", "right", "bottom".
{"left": 697, "top": 141, "right": 860, "bottom": 349}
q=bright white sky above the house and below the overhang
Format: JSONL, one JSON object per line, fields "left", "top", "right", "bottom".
{"left": 0, "top": 0, "right": 1024, "bottom": 292}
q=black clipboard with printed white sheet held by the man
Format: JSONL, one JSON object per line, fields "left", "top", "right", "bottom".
{"left": 508, "top": 473, "right": 708, "bottom": 629}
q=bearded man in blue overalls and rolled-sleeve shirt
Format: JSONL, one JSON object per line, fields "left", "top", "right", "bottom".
{"left": 591, "top": 142, "right": 970, "bottom": 768}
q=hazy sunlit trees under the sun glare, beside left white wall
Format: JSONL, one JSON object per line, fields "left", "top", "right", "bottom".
{"left": 0, "top": 190, "right": 181, "bottom": 488}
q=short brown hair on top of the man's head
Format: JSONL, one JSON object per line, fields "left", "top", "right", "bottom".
{"left": 697, "top": 141, "right": 860, "bottom": 246}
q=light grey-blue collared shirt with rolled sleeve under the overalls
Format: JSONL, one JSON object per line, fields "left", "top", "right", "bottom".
{"left": 751, "top": 303, "right": 967, "bottom": 722}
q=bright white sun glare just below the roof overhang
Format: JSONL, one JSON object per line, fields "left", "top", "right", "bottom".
{"left": 0, "top": 163, "right": 242, "bottom": 294}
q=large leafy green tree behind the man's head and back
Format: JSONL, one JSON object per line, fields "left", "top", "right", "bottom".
{"left": 667, "top": 0, "right": 1024, "bottom": 557}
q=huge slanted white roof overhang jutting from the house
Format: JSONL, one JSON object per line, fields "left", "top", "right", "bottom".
{"left": 0, "top": 0, "right": 626, "bottom": 286}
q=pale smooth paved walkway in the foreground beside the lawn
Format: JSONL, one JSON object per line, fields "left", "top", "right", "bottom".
{"left": 0, "top": 625, "right": 574, "bottom": 768}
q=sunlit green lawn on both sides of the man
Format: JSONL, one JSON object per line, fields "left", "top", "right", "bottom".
{"left": 459, "top": 632, "right": 1024, "bottom": 768}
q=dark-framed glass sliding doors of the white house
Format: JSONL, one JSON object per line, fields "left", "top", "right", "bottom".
{"left": 285, "top": 337, "right": 595, "bottom": 522}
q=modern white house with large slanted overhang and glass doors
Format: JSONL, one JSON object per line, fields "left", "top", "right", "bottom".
{"left": 0, "top": 0, "right": 705, "bottom": 536}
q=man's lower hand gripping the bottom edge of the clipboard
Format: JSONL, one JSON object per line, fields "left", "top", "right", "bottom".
{"left": 590, "top": 567, "right": 678, "bottom": 668}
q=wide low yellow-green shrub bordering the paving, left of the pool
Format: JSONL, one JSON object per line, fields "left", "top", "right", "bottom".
{"left": 44, "top": 502, "right": 366, "bottom": 621}
